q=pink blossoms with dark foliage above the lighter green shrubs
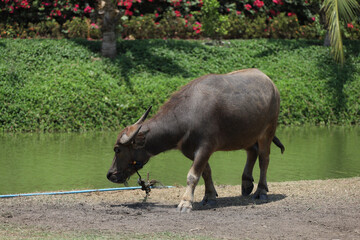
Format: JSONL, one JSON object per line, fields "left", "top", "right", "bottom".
{"left": 0, "top": 0, "right": 320, "bottom": 28}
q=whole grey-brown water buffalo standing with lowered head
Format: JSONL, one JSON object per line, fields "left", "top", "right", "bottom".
{"left": 107, "top": 69, "right": 284, "bottom": 212}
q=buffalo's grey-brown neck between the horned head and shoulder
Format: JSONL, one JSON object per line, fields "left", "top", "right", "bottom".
{"left": 142, "top": 112, "right": 184, "bottom": 155}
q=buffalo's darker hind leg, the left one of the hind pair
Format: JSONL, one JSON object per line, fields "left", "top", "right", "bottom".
{"left": 241, "top": 143, "right": 258, "bottom": 196}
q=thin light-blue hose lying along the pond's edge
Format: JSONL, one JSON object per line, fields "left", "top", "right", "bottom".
{"left": 0, "top": 186, "right": 173, "bottom": 198}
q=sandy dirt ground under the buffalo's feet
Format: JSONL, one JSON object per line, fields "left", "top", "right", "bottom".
{"left": 0, "top": 177, "right": 360, "bottom": 239}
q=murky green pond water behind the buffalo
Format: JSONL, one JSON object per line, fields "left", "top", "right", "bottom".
{"left": 0, "top": 126, "right": 360, "bottom": 194}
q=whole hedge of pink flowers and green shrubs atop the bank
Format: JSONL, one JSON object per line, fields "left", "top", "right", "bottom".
{"left": 0, "top": 0, "right": 359, "bottom": 39}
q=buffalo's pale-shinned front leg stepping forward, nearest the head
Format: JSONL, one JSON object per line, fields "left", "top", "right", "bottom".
{"left": 177, "top": 150, "right": 210, "bottom": 212}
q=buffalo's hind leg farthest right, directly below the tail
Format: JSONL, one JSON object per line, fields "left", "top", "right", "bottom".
{"left": 253, "top": 138, "right": 272, "bottom": 200}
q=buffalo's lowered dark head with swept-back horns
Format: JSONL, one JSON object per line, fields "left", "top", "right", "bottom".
{"left": 107, "top": 107, "right": 151, "bottom": 183}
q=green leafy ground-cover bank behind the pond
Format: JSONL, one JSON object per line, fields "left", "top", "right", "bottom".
{"left": 0, "top": 39, "right": 360, "bottom": 131}
